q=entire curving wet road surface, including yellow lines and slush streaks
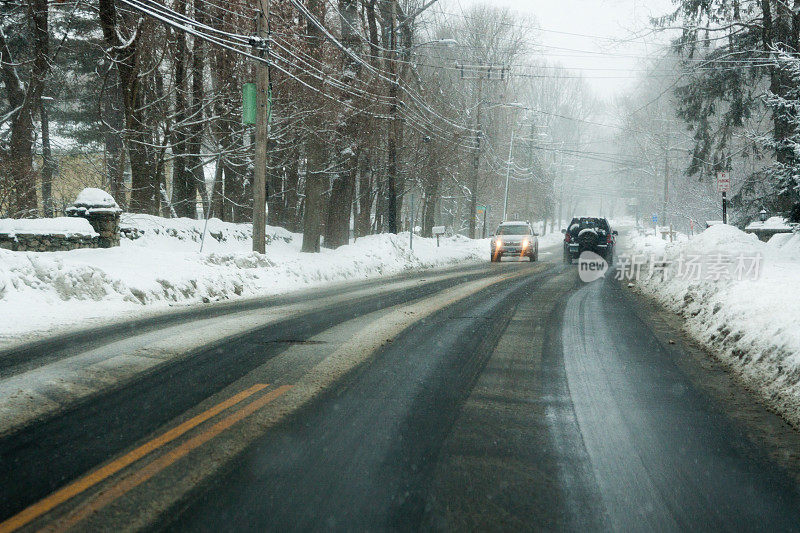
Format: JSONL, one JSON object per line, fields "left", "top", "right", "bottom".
{"left": 0, "top": 242, "right": 800, "bottom": 531}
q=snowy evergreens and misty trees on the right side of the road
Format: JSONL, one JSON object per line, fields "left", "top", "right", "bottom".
{"left": 618, "top": 0, "right": 800, "bottom": 224}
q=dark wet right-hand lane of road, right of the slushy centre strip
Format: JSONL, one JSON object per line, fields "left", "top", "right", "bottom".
{"left": 168, "top": 260, "right": 800, "bottom": 531}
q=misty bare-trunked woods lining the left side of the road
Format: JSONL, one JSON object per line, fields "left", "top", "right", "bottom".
{"left": 0, "top": 0, "right": 592, "bottom": 247}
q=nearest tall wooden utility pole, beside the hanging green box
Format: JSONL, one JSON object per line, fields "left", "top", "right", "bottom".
{"left": 253, "top": 0, "right": 269, "bottom": 254}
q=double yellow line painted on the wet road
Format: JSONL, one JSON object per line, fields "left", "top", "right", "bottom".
{"left": 0, "top": 383, "right": 292, "bottom": 533}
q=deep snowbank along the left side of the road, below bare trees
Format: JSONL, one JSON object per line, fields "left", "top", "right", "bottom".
{"left": 0, "top": 214, "right": 489, "bottom": 343}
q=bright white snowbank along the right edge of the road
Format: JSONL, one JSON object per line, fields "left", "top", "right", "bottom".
{"left": 619, "top": 225, "right": 800, "bottom": 427}
